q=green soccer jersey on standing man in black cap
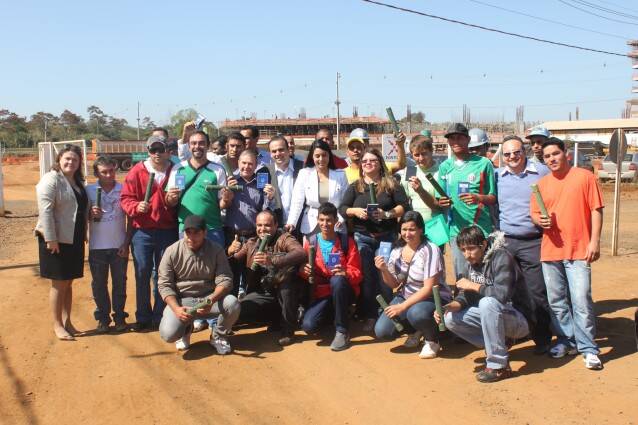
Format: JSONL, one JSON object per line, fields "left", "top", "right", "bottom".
{"left": 438, "top": 155, "right": 496, "bottom": 237}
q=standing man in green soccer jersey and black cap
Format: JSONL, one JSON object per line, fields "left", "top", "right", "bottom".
{"left": 438, "top": 123, "right": 496, "bottom": 280}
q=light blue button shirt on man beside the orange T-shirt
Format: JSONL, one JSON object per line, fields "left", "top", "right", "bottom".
{"left": 495, "top": 161, "right": 549, "bottom": 238}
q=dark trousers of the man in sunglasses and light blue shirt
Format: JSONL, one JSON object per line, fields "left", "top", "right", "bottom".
{"left": 505, "top": 236, "right": 552, "bottom": 345}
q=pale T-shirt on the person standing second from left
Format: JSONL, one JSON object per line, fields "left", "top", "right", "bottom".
{"left": 86, "top": 183, "right": 126, "bottom": 249}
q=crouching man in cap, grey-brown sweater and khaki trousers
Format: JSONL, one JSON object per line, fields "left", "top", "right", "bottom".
{"left": 158, "top": 215, "right": 240, "bottom": 355}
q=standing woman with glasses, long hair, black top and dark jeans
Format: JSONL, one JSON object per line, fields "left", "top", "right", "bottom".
{"left": 339, "top": 148, "right": 408, "bottom": 332}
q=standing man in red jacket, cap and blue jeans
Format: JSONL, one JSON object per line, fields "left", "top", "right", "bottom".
{"left": 120, "top": 135, "right": 179, "bottom": 331}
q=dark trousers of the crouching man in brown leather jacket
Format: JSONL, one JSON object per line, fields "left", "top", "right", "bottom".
{"left": 239, "top": 269, "right": 299, "bottom": 334}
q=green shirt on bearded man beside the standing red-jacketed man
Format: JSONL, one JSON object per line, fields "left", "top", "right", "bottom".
{"left": 166, "top": 161, "right": 226, "bottom": 232}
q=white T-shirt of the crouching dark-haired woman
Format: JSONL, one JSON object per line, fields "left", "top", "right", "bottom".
{"left": 388, "top": 242, "right": 451, "bottom": 300}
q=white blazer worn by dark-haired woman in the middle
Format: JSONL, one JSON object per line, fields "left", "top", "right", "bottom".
{"left": 286, "top": 167, "right": 348, "bottom": 234}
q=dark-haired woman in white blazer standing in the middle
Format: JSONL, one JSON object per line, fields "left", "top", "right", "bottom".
{"left": 285, "top": 140, "right": 348, "bottom": 235}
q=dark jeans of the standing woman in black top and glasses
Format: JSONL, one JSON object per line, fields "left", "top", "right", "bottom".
{"left": 354, "top": 232, "right": 395, "bottom": 319}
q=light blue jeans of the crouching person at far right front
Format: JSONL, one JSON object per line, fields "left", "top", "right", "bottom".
{"left": 445, "top": 297, "right": 529, "bottom": 369}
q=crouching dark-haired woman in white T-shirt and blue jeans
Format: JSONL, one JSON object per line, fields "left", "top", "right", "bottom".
{"left": 374, "top": 211, "right": 451, "bottom": 359}
